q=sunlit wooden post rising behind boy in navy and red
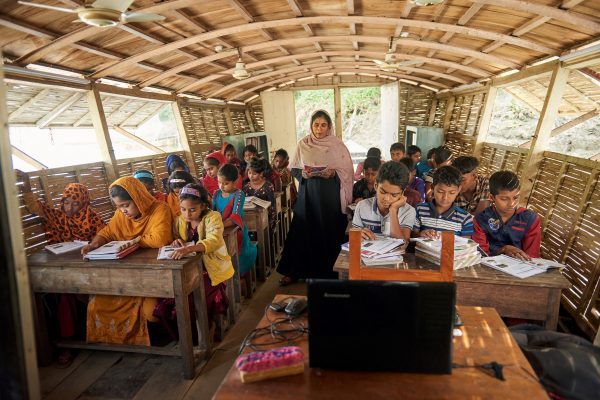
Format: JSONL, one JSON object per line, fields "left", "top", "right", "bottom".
{"left": 521, "top": 63, "right": 570, "bottom": 199}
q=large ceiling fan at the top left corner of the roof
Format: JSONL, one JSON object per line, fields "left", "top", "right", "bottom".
{"left": 18, "top": 0, "right": 165, "bottom": 27}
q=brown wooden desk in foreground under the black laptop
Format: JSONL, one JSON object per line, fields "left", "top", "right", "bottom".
{"left": 213, "top": 295, "right": 548, "bottom": 400}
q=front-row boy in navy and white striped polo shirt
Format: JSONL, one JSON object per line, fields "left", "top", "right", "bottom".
{"left": 414, "top": 166, "right": 473, "bottom": 239}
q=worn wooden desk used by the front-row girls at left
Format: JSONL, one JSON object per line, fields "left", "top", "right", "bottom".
{"left": 27, "top": 249, "right": 211, "bottom": 379}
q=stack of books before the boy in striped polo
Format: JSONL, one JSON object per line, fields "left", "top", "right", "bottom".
{"left": 411, "top": 236, "right": 481, "bottom": 269}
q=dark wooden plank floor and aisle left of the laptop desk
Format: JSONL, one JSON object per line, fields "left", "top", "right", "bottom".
{"left": 40, "top": 273, "right": 306, "bottom": 400}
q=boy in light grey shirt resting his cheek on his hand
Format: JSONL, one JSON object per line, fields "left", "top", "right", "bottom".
{"left": 352, "top": 161, "right": 415, "bottom": 247}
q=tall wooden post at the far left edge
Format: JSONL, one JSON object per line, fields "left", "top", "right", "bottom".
{"left": 0, "top": 60, "right": 41, "bottom": 399}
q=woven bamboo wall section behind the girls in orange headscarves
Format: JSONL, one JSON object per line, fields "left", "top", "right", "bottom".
{"left": 19, "top": 163, "right": 114, "bottom": 254}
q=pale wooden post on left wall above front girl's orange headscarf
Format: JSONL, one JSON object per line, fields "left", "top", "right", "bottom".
{"left": 87, "top": 84, "right": 118, "bottom": 182}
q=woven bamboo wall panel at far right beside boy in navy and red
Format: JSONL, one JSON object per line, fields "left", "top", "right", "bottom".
{"left": 528, "top": 152, "right": 600, "bottom": 337}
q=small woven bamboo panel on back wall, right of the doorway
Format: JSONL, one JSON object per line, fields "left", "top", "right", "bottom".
{"left": 398, "top": 84, "right": 434, "bottom": 143}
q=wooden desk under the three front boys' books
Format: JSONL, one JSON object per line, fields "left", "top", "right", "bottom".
{"left": 333, "top": 251, "right": 570, "bottom": 330}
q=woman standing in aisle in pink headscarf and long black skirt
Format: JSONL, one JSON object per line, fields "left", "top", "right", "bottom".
{"left": 277, "top": 110, "right": 354, "bottom": 285}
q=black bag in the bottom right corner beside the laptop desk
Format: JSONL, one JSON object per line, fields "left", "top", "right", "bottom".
{"left": 510, "top": 324, "right": 600, "bottom": 400}
